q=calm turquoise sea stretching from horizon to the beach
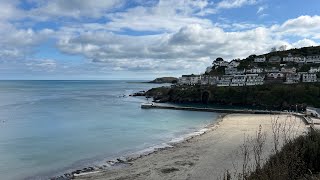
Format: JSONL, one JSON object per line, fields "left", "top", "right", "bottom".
{"left": 0, "top": 81, "right": 217, "bottom": 180}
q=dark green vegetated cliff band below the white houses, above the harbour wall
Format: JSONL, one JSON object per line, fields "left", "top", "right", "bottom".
{"left": 147, "top": 83, "right": 320, "bottom": 110}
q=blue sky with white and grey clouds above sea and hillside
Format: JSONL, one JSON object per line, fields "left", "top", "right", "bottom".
{"left": 0, "top": 0, "right": 320, "bottom": 80}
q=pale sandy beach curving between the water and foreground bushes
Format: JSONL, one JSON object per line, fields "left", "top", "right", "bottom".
{"left": 76, "top": 114, "right": 308, "bottom": 180}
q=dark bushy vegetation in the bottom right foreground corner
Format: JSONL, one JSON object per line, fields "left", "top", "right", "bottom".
{"left": 249, "top": 131, "right": 320, "bottom": 180}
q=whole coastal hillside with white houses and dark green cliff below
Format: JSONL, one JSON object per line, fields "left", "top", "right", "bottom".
{"left": 146, "top": 46, "right": 320, "bottom": 110}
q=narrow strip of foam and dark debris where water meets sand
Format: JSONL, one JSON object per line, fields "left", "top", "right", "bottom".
{"left": 49, "top": 113, "right": 228, "bottom": 180}
